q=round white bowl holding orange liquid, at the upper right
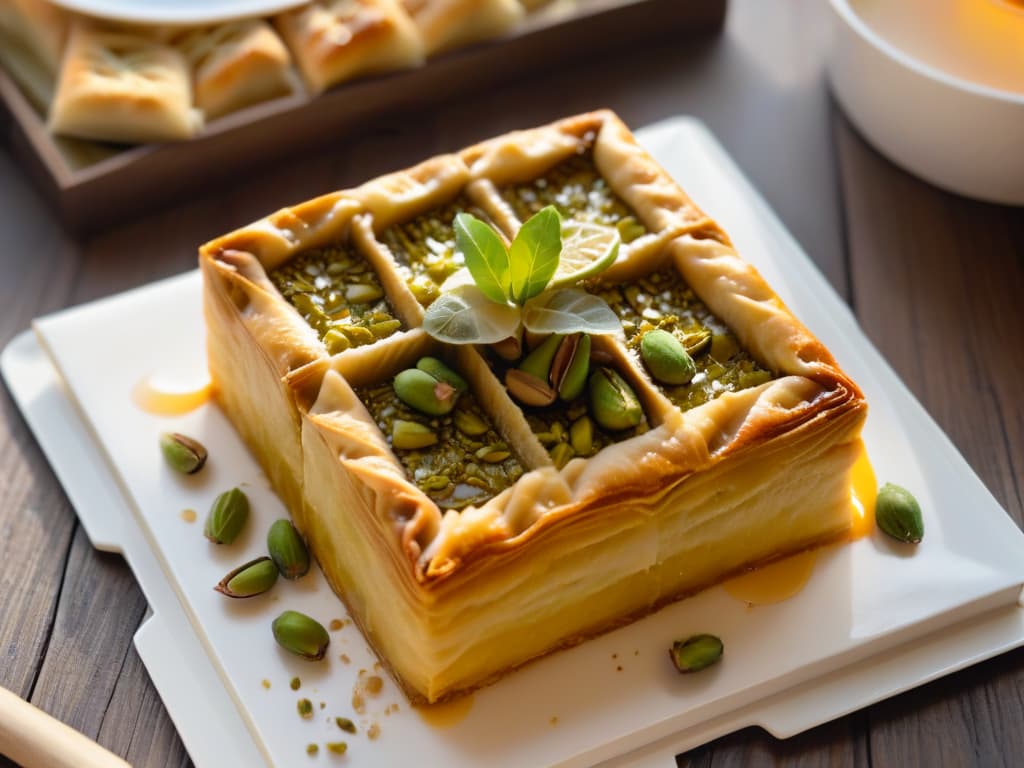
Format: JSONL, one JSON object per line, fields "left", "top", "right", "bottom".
{"left": 828, "top": 0, "right": 1024, "bottom": 206}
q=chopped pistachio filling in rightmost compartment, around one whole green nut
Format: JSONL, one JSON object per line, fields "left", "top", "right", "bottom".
{"left": 591, "top": 267, "right": 775, "bottom": 411}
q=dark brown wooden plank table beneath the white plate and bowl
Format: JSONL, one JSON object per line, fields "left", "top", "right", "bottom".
{"left": 0, "top": 0, "right": 1024, "bottom": 768}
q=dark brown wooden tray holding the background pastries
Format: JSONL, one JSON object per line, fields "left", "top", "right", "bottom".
{"left": 0, "top": 0, "right": 727, "bottom": 232}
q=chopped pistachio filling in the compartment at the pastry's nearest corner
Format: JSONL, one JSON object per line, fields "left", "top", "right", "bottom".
{"left": 356, "top": 382, "right": 524, "bottom": 509}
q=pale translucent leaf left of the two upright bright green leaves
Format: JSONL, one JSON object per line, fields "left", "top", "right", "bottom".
{"left": 423, "top": 286, "right": 520, "bottom": 344}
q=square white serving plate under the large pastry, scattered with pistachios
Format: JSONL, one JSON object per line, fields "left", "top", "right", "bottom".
{"left": 2, "top": 118, "right": 1024, "bottom": 767}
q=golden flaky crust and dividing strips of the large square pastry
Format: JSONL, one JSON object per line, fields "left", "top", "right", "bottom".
{"left": 201, "top": 112, "right": 866, "bottom": 701}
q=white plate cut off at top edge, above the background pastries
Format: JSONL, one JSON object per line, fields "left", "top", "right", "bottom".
{"left": 51, "top": 0, "right": 308, "bottom": 27}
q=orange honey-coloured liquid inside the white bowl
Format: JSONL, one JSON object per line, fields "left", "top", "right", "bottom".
{"left": 851, "top": 0, "right": 1024, "bottom": 94}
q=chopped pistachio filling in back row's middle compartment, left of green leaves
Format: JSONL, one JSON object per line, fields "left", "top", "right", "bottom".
{"left": 381, "top": 196, "right": 495, "bottom": 306}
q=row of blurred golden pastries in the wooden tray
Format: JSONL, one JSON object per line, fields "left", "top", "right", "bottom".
{"left": 0, "top": 0, "right": 543, "bottom": 144}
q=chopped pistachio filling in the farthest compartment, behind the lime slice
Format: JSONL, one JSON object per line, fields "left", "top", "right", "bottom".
{"left": 501, "top": 153, "right": 647, "bottom": 243}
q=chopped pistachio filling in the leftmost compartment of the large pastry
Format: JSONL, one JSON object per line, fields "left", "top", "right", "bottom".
{"left": 269, "top": 245, "right": 402, "bottom": 354}
